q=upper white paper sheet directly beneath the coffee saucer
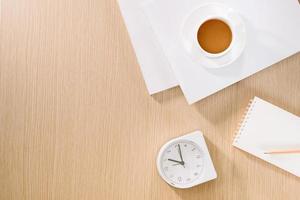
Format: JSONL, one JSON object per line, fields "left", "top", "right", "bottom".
{"left": 143, "top": 0, "right": 300, "bottom": 103}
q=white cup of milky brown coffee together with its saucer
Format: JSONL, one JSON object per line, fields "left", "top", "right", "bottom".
{"left": 181, "top": 3, "right": 246, "bottom": 68}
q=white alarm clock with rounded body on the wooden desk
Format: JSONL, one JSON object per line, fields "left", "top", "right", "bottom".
{"left": 157, "top": 131, "right": 217, "bottom": 188}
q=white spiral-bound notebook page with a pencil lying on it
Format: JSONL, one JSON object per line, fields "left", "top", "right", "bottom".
{"left": 233, "top": 97, "right": 300, "bottom": 177}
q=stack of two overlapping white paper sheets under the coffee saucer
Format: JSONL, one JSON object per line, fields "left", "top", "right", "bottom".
{"left": 119, "top": 0, "right": 300, "bottom": 103}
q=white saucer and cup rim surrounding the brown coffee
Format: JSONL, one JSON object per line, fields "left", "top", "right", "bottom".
{"left": 181, "top": 3, "right": 246, "bottom": 68}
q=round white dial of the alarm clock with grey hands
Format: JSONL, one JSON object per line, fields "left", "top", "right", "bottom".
{"left": 160, "top": 140, "right": 204, "bottom": 187}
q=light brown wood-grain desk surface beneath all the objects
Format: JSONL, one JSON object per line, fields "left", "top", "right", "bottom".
{"left": 0, "top": 0, "right": 300, "bottom": 200}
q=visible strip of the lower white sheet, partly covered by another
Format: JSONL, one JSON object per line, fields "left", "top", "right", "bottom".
{"left": 118, "top": 0, "right": 178, "bottom": 94}
